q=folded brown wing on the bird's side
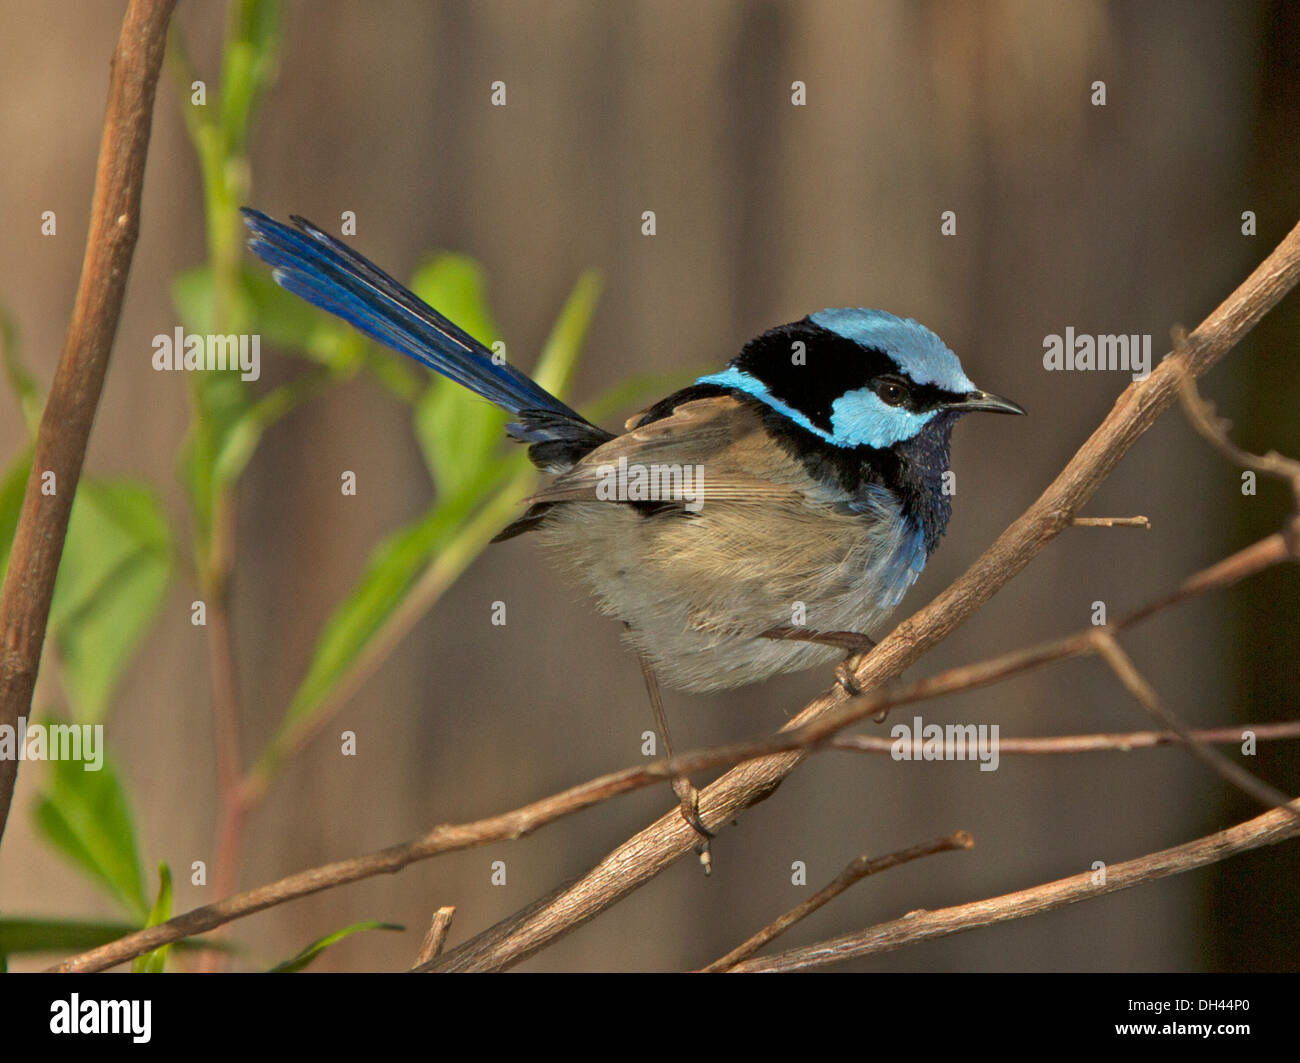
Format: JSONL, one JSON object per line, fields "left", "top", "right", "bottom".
{"left": 528, "top": 395, "right": 806, "bottom": 503}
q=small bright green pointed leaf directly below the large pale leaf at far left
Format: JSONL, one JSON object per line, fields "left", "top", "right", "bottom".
{"left": 35, "top": 738, "right": 150, "bottom": 925}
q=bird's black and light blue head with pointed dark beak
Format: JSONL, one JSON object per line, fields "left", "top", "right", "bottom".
{"left": 697, "top": 308, "right": 1024, "bottom": 448}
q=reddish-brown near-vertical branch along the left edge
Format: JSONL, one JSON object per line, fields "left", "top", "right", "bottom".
{"left": 0, "top": 0, "right": 176, "bottom": 834}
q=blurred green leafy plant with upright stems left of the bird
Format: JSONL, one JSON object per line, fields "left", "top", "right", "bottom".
{"left": 0, "top": 0, "right": 677, "bottom": 972}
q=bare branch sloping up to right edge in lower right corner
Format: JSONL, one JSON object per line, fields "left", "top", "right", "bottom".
{"left": 732, "top": 802, "right": 1300, "bottom": 973}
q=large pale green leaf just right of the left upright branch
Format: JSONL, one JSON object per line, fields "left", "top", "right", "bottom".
{"left": 49, "top": 480, "right": 172, "bottom": 721}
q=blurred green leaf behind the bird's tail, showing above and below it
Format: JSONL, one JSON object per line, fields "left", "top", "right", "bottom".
{"left": 411, "top": 255, "right": 506, "bottom": 494}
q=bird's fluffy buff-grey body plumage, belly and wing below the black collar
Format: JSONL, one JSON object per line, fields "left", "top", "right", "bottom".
{"left": 522, "top": 389, "right": 924, "bottom": 690}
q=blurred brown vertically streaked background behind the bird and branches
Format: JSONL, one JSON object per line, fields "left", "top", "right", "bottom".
{"left": 0, "top": 0, "right": 1300, "bottom": 971}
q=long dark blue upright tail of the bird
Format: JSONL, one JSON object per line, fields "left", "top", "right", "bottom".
{"left": 243, "top": 207, "right": 614, "bottom": 468}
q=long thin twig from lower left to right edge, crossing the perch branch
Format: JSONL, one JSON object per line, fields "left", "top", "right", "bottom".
{"left": 49, "top": 534, "right": 1291, "bottom": 971}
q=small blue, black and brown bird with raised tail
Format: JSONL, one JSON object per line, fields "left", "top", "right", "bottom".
{"left": 243, "top": 208, "right": 1026, "bottom": 834}
